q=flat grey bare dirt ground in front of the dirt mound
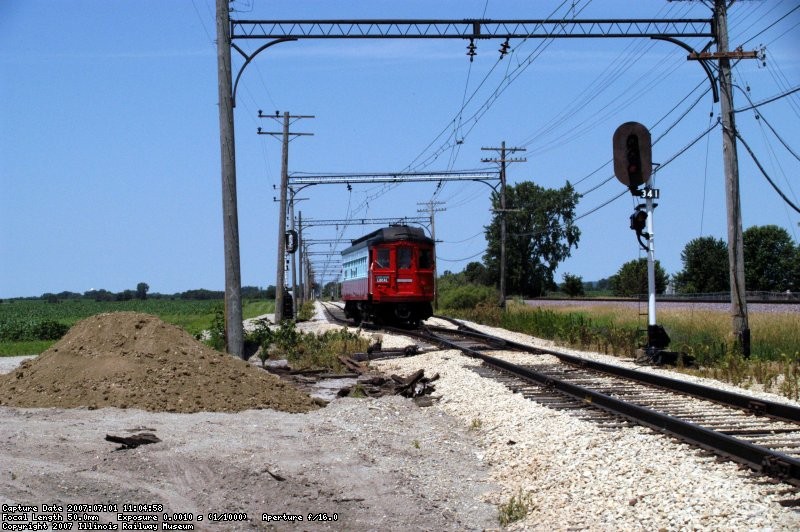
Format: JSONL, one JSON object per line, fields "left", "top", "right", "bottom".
{"left": 0, "top": 397, "right": 497, "bottom": 530}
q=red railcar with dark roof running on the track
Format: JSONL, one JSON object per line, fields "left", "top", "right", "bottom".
{"left": 342, "top": 225, "right": 436, "bottom": 325}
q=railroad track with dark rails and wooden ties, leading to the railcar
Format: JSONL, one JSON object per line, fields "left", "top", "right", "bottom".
{"left": 318, "top": 304, "right": 800, "bottom": 486}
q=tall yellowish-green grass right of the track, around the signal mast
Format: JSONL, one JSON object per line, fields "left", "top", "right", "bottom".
{"left": 450, "top": 302, "right": 800, "bottom": 400}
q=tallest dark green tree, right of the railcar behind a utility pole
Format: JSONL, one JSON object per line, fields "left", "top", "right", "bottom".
{"left": 484, "top": 181, "right": 580, "bottom": 297}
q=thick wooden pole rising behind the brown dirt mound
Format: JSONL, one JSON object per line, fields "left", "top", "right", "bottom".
{"left": 217, "top": 0, "right": 244, "bottom": 358}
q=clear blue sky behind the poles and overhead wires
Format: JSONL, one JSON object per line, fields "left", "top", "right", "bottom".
{"left": 0, "top": 0, "right": 800, "bottom": 298}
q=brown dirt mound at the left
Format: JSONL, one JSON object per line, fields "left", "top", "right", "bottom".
{"left": 0, "top": 312, "right": 317, "bottom": 412}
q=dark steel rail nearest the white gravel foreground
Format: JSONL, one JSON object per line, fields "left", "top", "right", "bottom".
{"left": 418, "top": 328, "right": 800, "bottom": 486}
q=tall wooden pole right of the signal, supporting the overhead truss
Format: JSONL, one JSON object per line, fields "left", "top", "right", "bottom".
{"left": 714, "top": 0, "right": 750, "bottom": 357}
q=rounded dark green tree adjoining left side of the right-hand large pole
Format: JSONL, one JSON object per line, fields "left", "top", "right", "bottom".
{"left": 674, "top": 236, "right": 730, "bottom": 294}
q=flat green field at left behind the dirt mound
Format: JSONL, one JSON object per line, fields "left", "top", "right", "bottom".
{"left": 0, "top": 299, "right": 275, "bottom": 356}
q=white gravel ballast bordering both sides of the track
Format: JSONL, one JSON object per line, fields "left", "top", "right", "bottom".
{"left": 372, "top": 316, "right": 800, "bottom": 530}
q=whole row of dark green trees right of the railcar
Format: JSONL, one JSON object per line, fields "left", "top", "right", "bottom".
{"left": 450, "top": 182, "right": 800, "bottom": 297}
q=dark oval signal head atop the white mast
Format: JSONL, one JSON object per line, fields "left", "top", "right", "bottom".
{"left": 613, "top": 122, "right": 653, "bottom": 192}
